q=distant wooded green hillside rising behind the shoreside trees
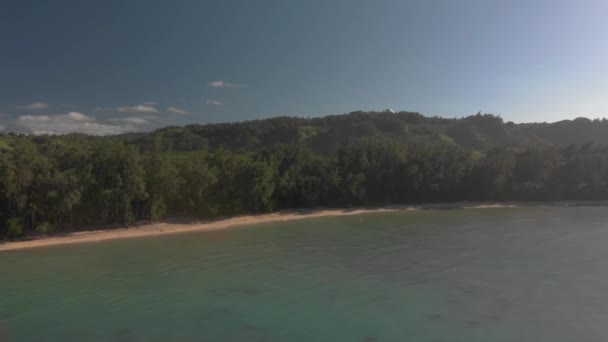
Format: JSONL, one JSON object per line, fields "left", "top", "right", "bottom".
{"left": 122, "top": 112, "right": 608, "bottom": 153}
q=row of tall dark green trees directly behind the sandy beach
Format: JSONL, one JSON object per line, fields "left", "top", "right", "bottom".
{"left": 0, "top": 135, "right": 608, "bottom": 238}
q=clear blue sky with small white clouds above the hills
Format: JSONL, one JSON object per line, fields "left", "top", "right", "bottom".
{"left": 0, "top": 0, "right": 608, "bottom": 134}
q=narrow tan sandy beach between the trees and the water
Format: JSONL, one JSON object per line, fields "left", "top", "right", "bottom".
{"left": 0, "top": 202, "right": 607, "bottom": 252}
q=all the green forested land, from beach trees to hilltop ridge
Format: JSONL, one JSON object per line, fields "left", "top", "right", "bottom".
{"left": 0, "top": 112, "right": 608, "bottom": 238}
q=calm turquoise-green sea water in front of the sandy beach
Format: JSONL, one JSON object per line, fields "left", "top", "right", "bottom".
{"left": 0, "top": 207, "right": 608, "bottom": 342}
